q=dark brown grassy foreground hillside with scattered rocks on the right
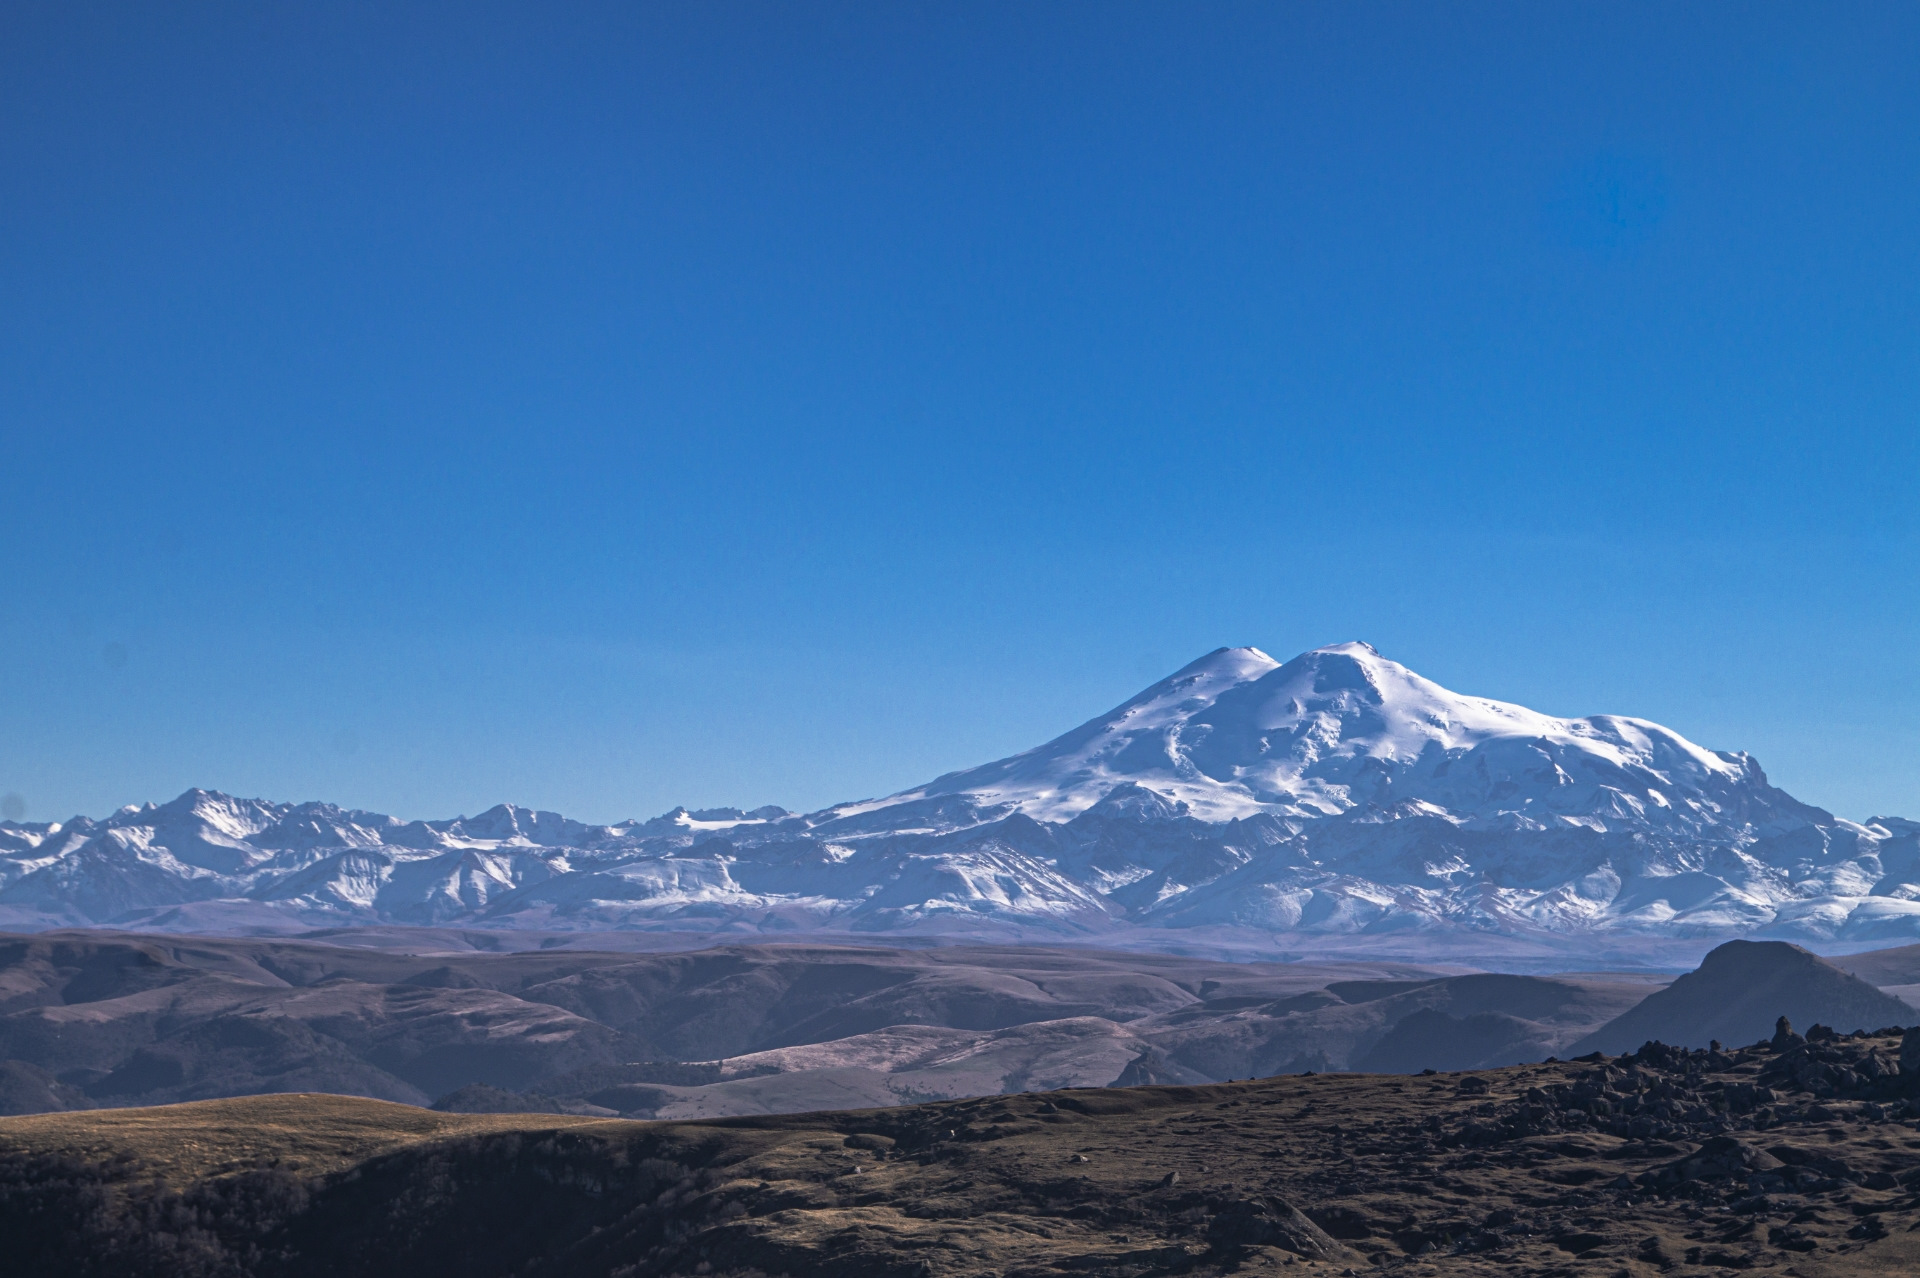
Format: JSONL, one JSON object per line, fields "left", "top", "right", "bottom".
{"left": 0, "top": 1036, "right": 1920, "bottom": 1278}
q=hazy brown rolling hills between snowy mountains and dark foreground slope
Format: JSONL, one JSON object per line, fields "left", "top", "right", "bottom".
{"left": 0, "top": 931, "right": 1920, "bottom": 1119}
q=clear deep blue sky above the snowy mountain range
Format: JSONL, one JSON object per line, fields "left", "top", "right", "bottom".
{"left": 0, "top": 0, "right": 1920, "bottom": 819}
